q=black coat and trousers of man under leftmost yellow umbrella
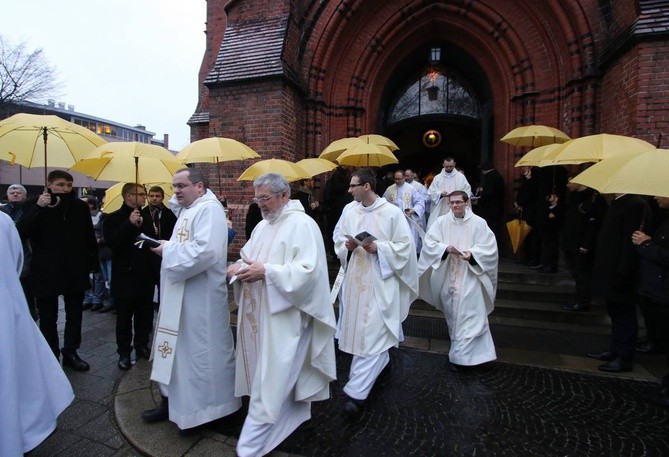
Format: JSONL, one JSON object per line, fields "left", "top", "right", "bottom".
{"left": 17, "top": 193, "right": 100, "bottom": 357}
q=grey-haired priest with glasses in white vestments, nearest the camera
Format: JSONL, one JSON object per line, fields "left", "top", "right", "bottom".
{"left": 228, "top": 173, "right": 336, "bottom": 457}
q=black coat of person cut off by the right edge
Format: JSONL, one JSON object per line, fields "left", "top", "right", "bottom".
{"left": 636, "top": 211, "right": 669, "bottom": 306}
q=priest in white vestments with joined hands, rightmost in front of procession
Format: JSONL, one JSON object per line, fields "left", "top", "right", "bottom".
{"left": 418, "top": 191, "right": 498, "bottom": 371}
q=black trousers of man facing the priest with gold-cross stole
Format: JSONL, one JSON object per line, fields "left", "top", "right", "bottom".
{"left": 114, "top": 294, "right": 153, "bottom": 355}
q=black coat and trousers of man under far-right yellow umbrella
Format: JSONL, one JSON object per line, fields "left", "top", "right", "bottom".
{"left": 592, "top": 195, "right": 650, "bottom": 362}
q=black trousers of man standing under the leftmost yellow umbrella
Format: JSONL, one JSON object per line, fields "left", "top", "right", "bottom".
{"left": 35, "top": 291, "right": 84, "bottom": 358}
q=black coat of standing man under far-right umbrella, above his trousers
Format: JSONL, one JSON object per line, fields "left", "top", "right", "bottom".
{"left": 592, "top": 195, "right": 649, "bottom": 303}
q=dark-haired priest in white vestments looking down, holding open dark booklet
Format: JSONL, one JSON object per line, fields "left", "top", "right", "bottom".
{"left": 335, "top": 169, "right": 418, "bottom": 418}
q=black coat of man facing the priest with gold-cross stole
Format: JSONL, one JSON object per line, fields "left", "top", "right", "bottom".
{"left": 102, "top": 204, "right": 156, "bottom": 298}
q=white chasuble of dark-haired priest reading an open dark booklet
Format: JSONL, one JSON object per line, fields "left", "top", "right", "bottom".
{"left": 335, "top": 198, "right": 418, "bottom": 357}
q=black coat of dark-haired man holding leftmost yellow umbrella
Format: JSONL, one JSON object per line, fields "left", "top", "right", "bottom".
{"left": 16, "top": 193, "right": 100, "bottom": 297}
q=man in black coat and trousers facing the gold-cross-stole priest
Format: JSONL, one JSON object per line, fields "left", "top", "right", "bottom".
{"left": 102, "top": 183, "right": 155, "bottom": 370}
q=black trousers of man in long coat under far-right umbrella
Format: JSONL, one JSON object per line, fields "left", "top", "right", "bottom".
{"left": 606, "top": 300, "right": 639, "bottom": 362}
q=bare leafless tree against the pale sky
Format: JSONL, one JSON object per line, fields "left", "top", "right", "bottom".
{"left": 0, "top": 35, "right": 62, "bottom": 105}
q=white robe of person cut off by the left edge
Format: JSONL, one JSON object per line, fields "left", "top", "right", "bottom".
{"left": 0, "top": 212, "right": 74, "bottom": 456}
